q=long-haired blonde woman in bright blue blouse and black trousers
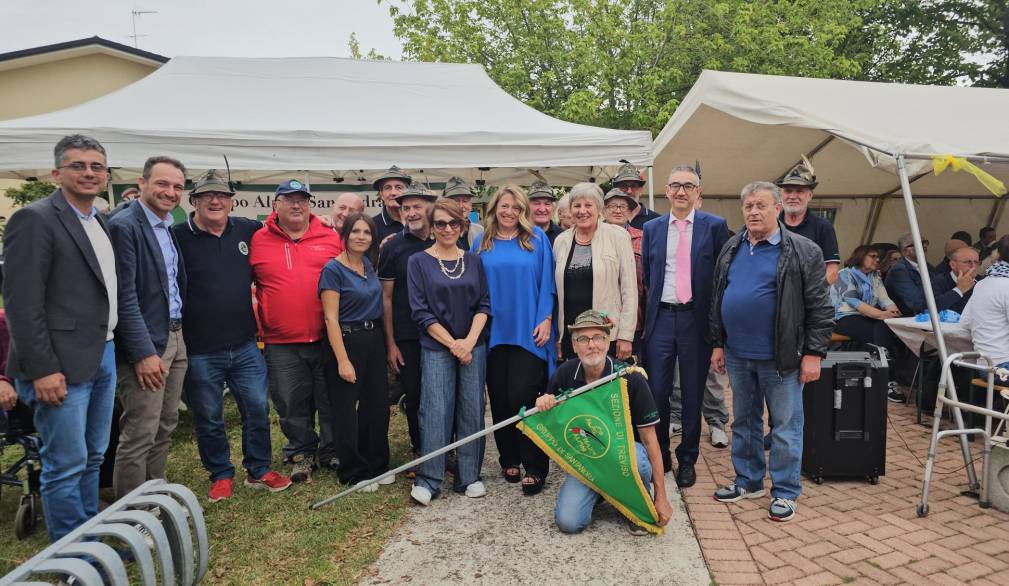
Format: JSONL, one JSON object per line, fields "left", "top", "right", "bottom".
{"left": 473, "top": 186, "right": 557, "bottom": 495}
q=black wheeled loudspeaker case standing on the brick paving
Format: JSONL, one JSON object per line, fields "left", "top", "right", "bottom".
{"left": 802, "top": 352, "right": 890, "bottom": 484}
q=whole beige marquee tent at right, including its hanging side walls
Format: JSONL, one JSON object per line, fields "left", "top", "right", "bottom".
{"left": 652, "top": 71, "right": 1009, "bottom": 261}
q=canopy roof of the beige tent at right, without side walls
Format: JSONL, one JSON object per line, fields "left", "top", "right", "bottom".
{"left": 652, "top": 71, "right": 1009, "bottom": 197}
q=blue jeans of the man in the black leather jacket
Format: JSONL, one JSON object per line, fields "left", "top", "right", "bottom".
{"left": 725, "top": 349, "right": 803, "bottom": 500}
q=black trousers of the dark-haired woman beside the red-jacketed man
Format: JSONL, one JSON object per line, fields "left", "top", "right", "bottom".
{"left": 322, "top": 329, "right": 388, "bottom": 484}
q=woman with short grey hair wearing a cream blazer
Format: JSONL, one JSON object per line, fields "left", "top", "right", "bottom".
{"left": 554, "top": 183, "right": 639, "bottom": 360}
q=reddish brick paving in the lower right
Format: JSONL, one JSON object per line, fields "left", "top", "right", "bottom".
{"left": 683, "top": 393, "right": 1009, "bottom": 586}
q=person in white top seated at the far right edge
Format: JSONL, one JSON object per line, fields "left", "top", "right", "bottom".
{"left": 961, "top": 236, "right": 1009, "bottom": 367}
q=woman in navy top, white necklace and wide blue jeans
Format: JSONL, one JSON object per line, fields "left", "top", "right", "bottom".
{"left": 407, "top": 199, "right": 490, "bottom": 505}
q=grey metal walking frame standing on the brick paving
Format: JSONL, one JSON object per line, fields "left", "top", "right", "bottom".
{"left": 917, "top": 352, "right": 1009, "bottom": 517}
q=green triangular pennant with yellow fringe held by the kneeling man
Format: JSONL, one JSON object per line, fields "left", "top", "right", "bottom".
{"left": 518, "top": 377, "right": 662, "bottom": 535}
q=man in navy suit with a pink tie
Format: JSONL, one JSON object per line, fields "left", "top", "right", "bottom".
{"left": 641, "top": 165, "right": 728, "bottom": 487}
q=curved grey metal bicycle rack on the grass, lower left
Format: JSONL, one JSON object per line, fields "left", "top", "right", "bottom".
{"left": 0, "top": 480, "right": 208, "bottom": 586}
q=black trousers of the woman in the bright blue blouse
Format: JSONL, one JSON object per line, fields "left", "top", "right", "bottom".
{"left": 487, "top": 345, "right": 550, "bottom": 478}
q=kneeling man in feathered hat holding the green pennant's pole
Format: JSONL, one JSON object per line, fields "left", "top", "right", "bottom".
{"left": 536, "top": 310, "right": 673, "bottom": 535}
